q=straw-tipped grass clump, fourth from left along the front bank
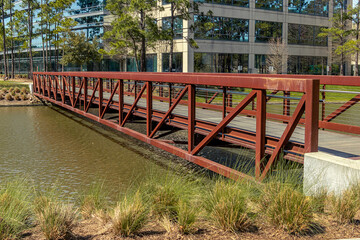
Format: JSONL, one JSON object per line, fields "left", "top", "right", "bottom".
{"left": 110, "top": 192, "right": 149, "bottom": 236}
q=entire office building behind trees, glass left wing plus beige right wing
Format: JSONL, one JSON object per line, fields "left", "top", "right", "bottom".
{"left": 0, "top": 0, "right": 352, "bottom": 75}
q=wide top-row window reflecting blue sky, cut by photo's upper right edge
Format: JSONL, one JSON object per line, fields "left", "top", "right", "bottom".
{"left": 288, "top": 0, "right": 329, "bottom": 17}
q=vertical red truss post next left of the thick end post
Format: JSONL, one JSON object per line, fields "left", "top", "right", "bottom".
{"left": 255, "top": 90, "right": 266, "bottom": 179}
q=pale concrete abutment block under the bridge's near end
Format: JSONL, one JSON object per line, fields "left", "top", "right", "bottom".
{"left": 304, "top": 152, "right": 360, "bottom": 195}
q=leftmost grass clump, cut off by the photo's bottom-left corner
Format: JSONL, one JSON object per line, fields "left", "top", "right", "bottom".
{"left": 0, "top": 180, "right": 31, "bottom": 239}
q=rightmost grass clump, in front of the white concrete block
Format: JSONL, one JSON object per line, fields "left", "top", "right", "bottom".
{"left": 330, "top": 189, "right": 360, "bottom": 223}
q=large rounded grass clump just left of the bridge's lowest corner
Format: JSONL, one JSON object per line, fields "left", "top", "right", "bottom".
{"left": 203, "top": 179, "right": 250, "bottom": 232}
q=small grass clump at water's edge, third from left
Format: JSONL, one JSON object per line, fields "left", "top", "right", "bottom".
{"left": 79, "top": 182, "right": 107, "bottom": 219}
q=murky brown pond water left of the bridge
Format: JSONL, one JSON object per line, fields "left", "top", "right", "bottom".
{"left": 0, "top": 107, "right": 160, "bottom": 198}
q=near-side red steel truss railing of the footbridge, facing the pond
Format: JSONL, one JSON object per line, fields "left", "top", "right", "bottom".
{"left": 34, "top": 72, "right": 320, "bottom": 179}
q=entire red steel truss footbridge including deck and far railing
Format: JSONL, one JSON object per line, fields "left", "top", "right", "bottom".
{"left": 33, "top": 72, "right": 360, "bottom": 180}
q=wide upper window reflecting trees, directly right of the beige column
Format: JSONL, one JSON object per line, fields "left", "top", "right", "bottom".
{"left": 194, "top": 15, "right": 249, "bottom": 42}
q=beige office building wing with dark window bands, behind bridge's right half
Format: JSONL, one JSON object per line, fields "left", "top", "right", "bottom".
{"left": 157, "top": 0, "right": 351, "bottom": 74}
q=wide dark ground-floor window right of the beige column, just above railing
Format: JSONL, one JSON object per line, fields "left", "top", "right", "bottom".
{"left": 194, "top": 53, "right": 249, "bottom": 73}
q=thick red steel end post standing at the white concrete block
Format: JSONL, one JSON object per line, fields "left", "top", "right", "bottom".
{"left": 304, "top": 80, "right": 320, "bottom": 153}
